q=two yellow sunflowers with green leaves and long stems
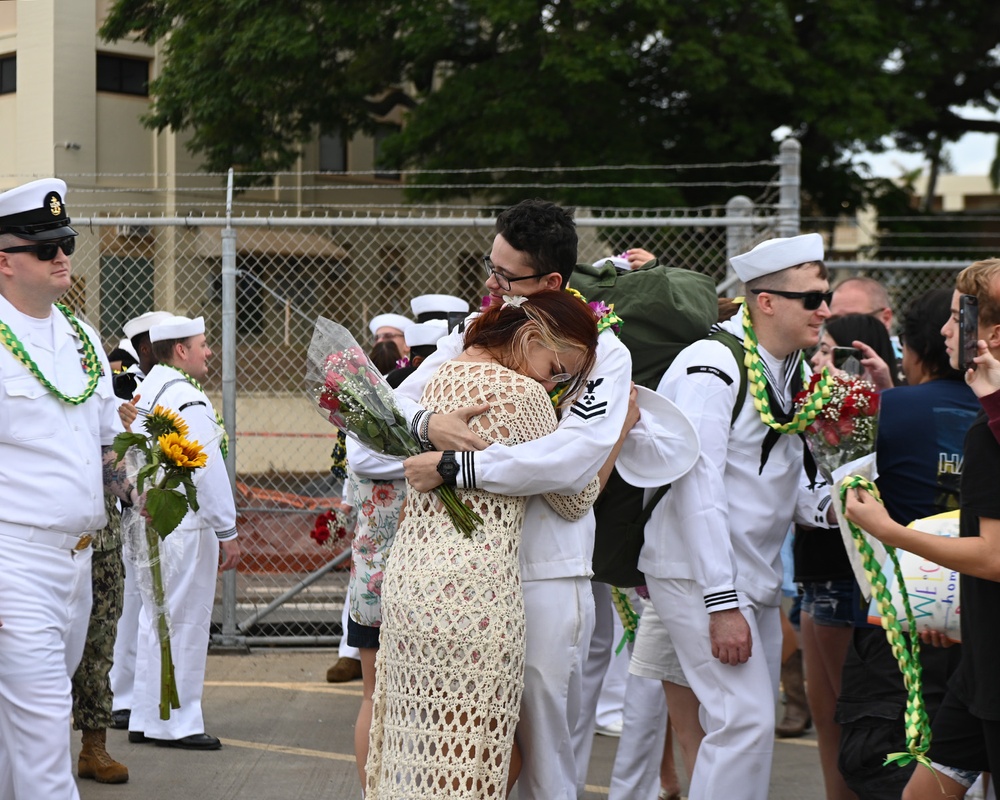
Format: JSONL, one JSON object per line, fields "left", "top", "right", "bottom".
{"left": 113, "top": 406, "right": 208, "bottom": 719}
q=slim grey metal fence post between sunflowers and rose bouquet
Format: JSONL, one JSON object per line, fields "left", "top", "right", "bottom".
{"left": 219, "top": 169, "right": 246, "bottom": 647}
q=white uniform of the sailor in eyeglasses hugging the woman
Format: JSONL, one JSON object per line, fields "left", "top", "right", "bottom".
{"left": 396, "top": 314, "right": 641, "bottom": 800}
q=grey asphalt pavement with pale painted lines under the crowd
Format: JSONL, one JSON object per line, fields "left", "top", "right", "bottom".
{"left": 73, "top": 648, "right": 824, "bottom": 800}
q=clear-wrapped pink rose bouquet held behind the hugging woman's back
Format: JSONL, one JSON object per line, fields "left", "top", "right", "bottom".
{"left": 306, "top": 317, "right": 482, "bottom": 537}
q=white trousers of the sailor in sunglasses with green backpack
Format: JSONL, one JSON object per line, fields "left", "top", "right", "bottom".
{"left": 647, "top": 576, "right": 781, "bottom": 800}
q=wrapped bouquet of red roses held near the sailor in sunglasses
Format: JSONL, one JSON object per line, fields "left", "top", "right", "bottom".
{"left": 796, "top": 372, "right": 886, "bottom": 599}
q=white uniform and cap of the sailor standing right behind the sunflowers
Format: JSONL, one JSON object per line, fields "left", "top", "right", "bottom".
{"left": 129, "top": 317, "right": 237, "bottom": 740}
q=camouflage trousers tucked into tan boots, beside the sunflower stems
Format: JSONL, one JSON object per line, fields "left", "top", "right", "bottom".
{"left": 73, "top": 546, "right": 125, "bottom": 731}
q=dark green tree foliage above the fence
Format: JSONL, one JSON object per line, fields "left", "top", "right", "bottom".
{"left": 102, "top": 0, "right": 1000, "bottom": 214}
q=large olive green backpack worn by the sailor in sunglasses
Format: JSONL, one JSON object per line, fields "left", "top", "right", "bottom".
{"left": 570, "top": 262, "right": 746, "bottom": 588}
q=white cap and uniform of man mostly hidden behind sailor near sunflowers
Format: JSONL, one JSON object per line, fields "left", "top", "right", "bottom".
{"left": 108, "top": 311, "right": 174, "bottom": 711}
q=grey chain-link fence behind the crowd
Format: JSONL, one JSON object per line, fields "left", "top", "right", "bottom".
{"left": 47, "top": 144, "right": 1000, "bottom": 645}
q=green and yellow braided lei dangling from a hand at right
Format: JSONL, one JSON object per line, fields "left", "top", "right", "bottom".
{"left": 840, "top": 475, "right": 932, "bottom": 769}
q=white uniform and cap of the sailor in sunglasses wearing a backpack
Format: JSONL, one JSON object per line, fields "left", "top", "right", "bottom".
{"left": 639, "top": 235, "right": 829, "bottom": 800}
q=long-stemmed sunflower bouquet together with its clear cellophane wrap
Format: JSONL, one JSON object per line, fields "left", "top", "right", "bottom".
{"left": 114, "top": 406, "right": 222, "bottom": 719}
